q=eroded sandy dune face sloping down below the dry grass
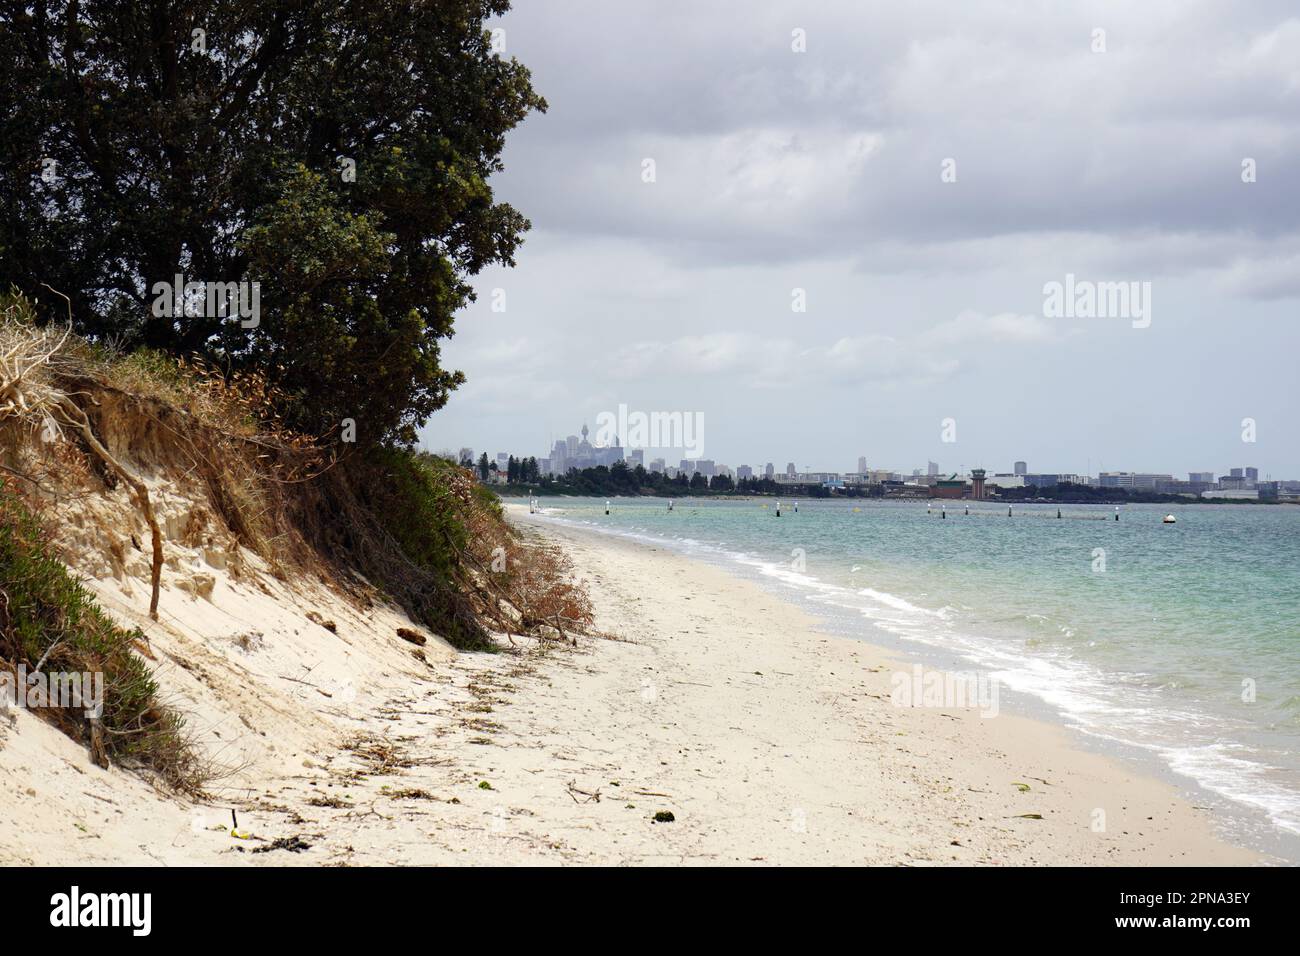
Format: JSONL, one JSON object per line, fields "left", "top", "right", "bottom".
{"left": 0, "top": 382, "right": 455, "bottom": 864}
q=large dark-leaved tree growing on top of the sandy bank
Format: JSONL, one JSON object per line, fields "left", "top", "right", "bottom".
{"left": 0, "top": 0, "right": 546, "bottom": 441}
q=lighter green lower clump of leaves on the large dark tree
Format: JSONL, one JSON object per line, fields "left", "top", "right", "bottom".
{"left": 235, "top": 165, "right": 464, "bottom": 444}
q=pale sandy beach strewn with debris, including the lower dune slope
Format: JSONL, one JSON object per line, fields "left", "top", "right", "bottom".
{"left": 0, "top": 507, "right": 1261, "bottom": 865}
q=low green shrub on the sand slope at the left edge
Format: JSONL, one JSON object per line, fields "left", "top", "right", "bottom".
{"left": 0, "top": 486, "right": 198, "bottom": 790}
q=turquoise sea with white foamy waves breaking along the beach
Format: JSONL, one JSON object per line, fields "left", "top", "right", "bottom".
{"left": 517, "top": 498, "right": 1300, "bottom": 843}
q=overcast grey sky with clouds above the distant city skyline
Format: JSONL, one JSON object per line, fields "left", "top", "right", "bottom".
{"left": 424, "top": 0, "right": 1300, "bottom": 477}
